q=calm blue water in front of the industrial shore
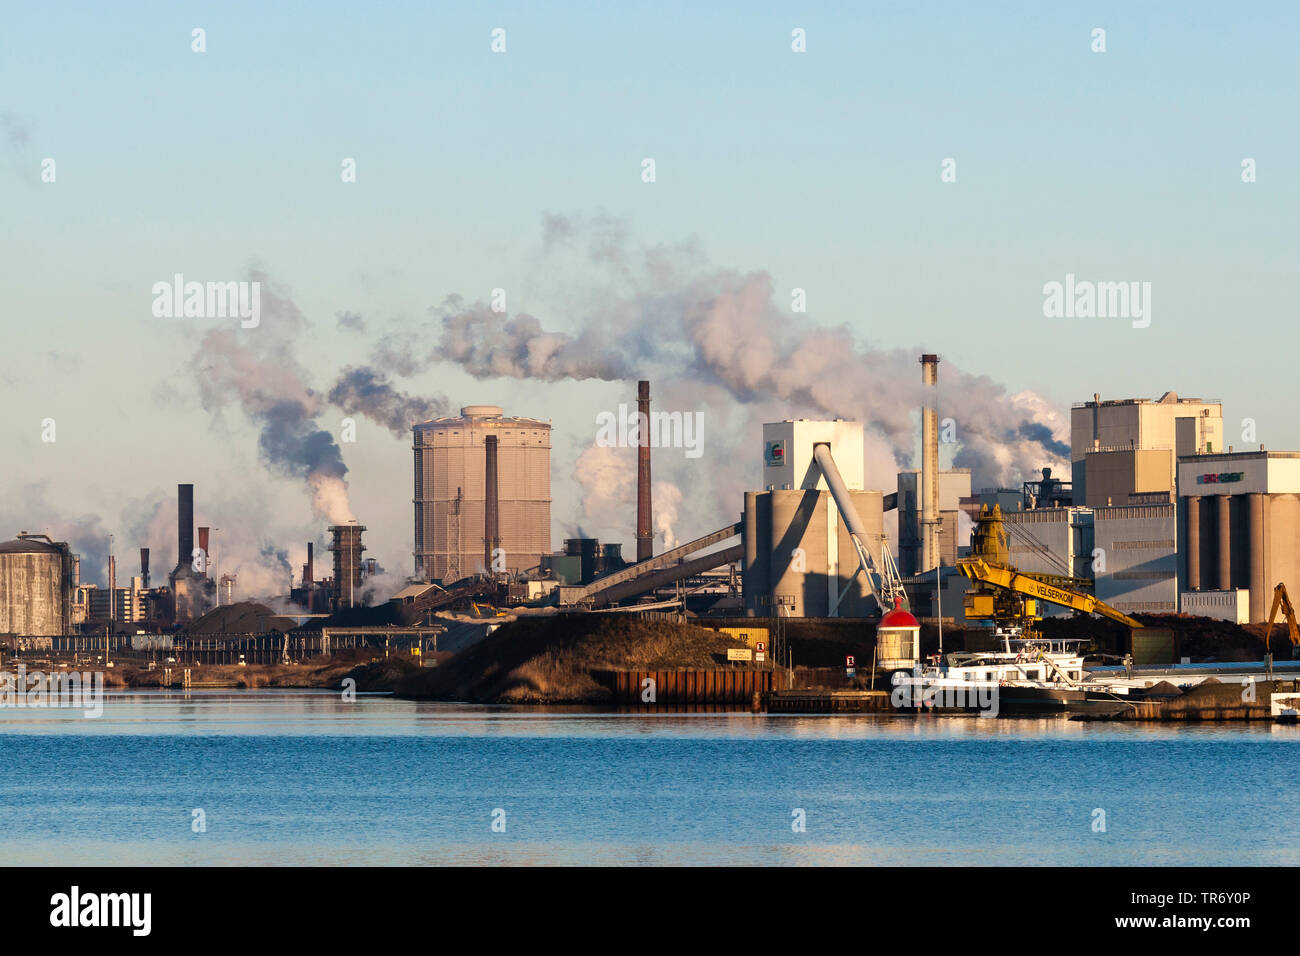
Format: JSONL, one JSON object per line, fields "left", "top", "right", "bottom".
{"left": 0, "top": 691, "right": 1300, "bottom": 865}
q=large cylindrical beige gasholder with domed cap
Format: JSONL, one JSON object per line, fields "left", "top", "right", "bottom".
{"left": 413, "top": 405, "right": 551, "bottom": 581}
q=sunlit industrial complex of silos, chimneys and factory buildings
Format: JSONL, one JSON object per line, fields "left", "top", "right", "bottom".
{"left": 0, "top": 354, "right": 1300, "bottom": 665}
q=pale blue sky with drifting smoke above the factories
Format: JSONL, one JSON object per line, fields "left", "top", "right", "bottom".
{"left": 0, "top": 3, "right": 1300, "bottom": 591}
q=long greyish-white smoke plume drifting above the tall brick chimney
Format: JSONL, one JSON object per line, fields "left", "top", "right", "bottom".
{"left": 436, "top": 216, "right": 1069, "bottom": 486}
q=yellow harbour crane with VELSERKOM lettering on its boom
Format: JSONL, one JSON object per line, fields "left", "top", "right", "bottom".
{"left": 957, "top": 505, "right": 1141, "bottom": 631}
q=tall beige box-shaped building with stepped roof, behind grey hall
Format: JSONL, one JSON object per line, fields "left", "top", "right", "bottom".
{"left": 1070, "top": 392, "right": 1223, "bottom": 507}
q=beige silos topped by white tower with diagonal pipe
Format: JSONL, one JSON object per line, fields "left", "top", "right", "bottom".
{"left": 742, "top": 419, "right": 884, "bottom": 618}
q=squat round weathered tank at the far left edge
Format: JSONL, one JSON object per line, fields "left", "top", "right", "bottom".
{"left": 0, "top": 532, "right": 78, "bottom": 637}
